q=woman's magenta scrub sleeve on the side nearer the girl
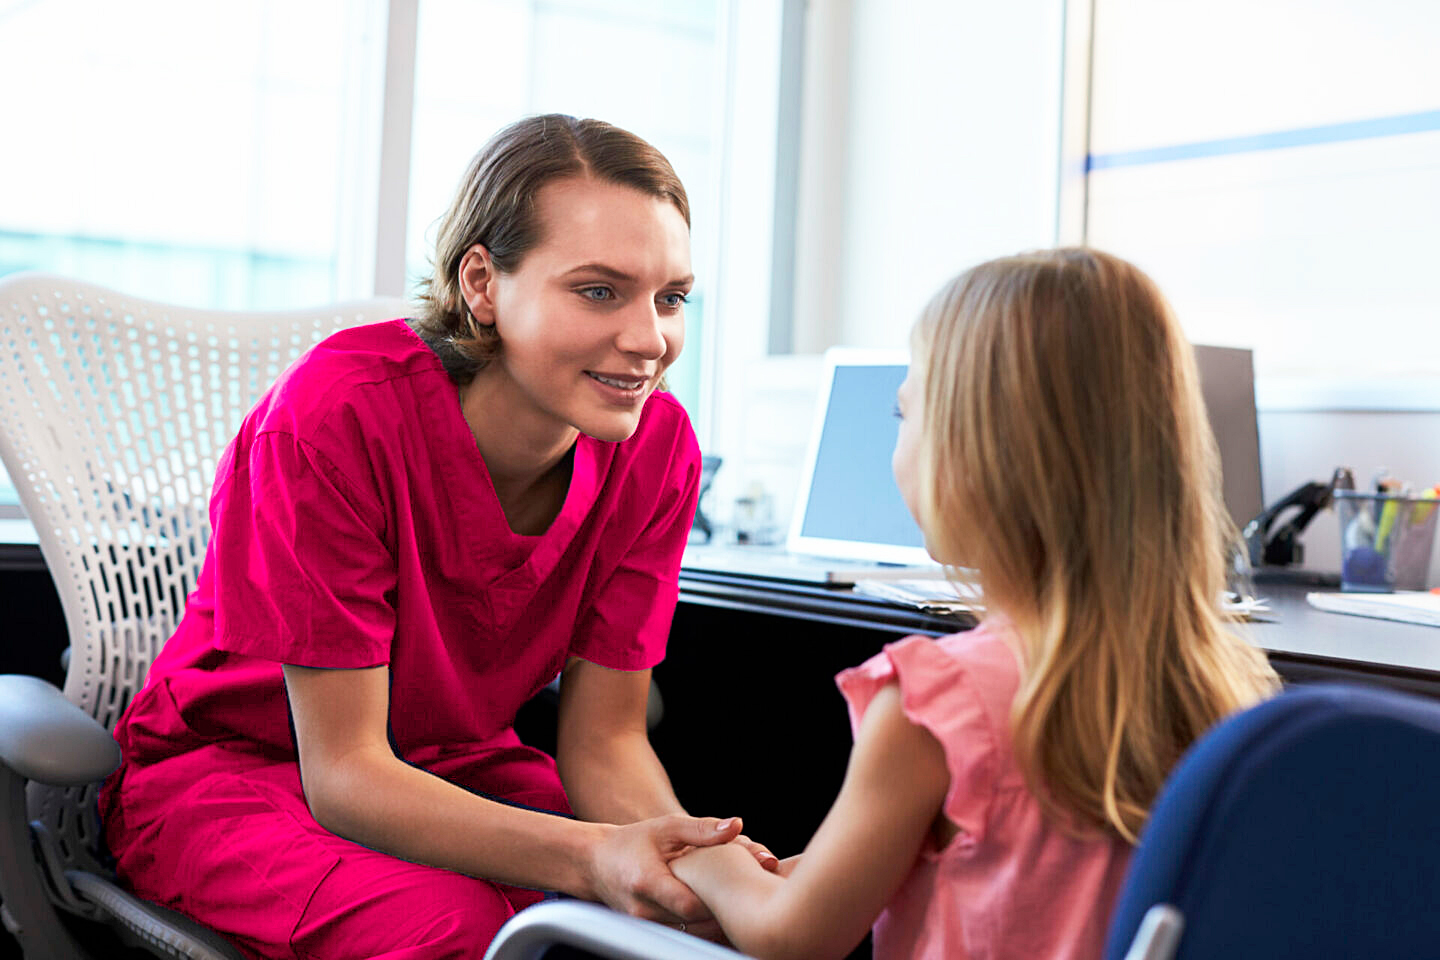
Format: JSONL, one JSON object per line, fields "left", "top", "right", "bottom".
{"left": 570, "top": 406, "right": 700, "bottom": 671}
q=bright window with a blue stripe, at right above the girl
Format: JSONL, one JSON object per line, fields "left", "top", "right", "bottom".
{"left": 1086, "top": 0, "right": 1440, "bottom": 403}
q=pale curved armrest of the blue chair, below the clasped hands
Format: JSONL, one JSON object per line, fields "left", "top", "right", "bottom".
{"left": 485, "top": 900, "right": 746, "bottom": 960}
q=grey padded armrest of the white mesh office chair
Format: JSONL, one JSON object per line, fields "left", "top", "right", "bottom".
{"left": 0, "top": 674, "right": 120, "bottom": 787}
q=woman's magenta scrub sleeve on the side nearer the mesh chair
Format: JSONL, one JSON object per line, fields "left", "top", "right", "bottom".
{"left": 210, "top": 432, "right": 396, "bottom": 668}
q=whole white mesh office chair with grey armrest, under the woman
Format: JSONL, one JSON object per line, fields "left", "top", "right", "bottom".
{"left": 0, "top": 273, "right": 406, "bottom": 960}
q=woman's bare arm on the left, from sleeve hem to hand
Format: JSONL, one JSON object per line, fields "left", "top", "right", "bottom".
{"left": 285, "top": 665, "right": 740, "bottom": 923}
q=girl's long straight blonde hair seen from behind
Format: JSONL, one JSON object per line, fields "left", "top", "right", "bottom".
{"left": 914, "top": 248, "right": 1277, "bottom": 843}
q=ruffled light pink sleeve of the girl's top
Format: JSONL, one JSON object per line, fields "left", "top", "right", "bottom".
{"left": 835, "top": 636, "right": 999, "bottom": 842}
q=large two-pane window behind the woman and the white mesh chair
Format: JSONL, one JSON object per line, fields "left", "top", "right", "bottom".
{"left": 0, "top": 0, "right": 778, "bottom": 512}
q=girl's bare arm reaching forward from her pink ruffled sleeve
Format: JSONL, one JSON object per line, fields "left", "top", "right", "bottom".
{"left": 671, "top": 684, "right": 950, "bottom": 960}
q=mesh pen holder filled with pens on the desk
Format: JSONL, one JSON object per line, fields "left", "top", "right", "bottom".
{"left": 1335, "top": 489, "right": 1440, "bottom": 593}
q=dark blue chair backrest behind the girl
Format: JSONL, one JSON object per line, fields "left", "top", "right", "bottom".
{"left": 1104, "top": 685, "right": 1440, "bottom": 960}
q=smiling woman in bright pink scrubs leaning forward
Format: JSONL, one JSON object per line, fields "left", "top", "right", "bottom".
{"left": 102, "top": 115, "right": 773, "bottom": 960}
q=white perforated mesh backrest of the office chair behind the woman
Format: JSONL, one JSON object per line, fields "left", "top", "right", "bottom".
{"left": 0, "top": 273, "right": 406, "bottom": 892}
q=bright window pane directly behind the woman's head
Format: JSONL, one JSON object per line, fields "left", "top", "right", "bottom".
{"left": 406, "top": 0, "right": 724, "bottom": 416}
